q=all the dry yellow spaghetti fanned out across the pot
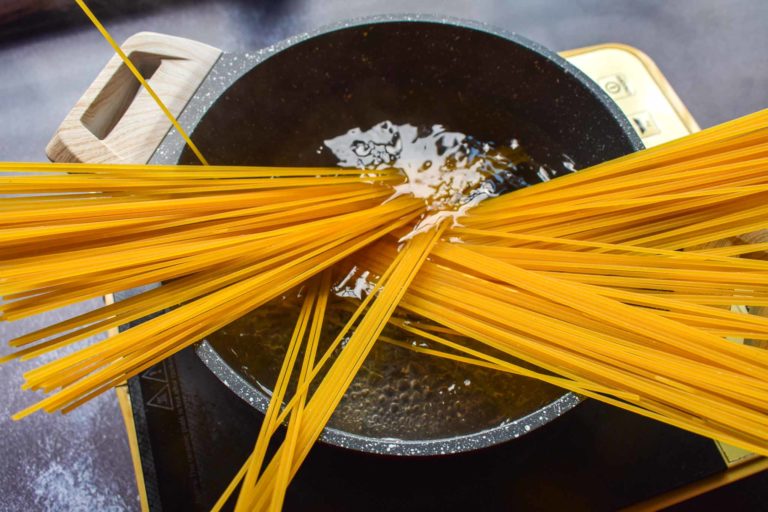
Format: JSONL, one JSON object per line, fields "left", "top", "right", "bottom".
{"left": 0, "top": 112, "right": 768, "bottom": 510}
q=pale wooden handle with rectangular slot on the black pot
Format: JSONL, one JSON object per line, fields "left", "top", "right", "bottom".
{"left": 45, "top": 32, "right": 221, "bottom": 163}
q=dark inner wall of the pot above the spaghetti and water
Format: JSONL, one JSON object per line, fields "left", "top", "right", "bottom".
{"left": 181, "top": 22, "right": 639, "bottom": 167}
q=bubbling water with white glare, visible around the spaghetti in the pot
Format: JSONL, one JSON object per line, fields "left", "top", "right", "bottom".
{"left": 208, "top": 121, "right": 573, "bottom": 440}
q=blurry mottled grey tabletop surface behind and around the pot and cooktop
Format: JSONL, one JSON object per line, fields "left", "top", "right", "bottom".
{"left": 0, "top": 0, "right": 768, "bottom": 510}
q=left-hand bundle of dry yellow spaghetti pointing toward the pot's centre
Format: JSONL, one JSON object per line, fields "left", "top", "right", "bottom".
{"left": 0, "top": 164, "right": 422, "bottom": 416}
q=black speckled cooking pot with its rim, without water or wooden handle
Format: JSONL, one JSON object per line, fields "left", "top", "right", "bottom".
{"left": 152, "top": 17, "right": 642, "bottom": 455}
